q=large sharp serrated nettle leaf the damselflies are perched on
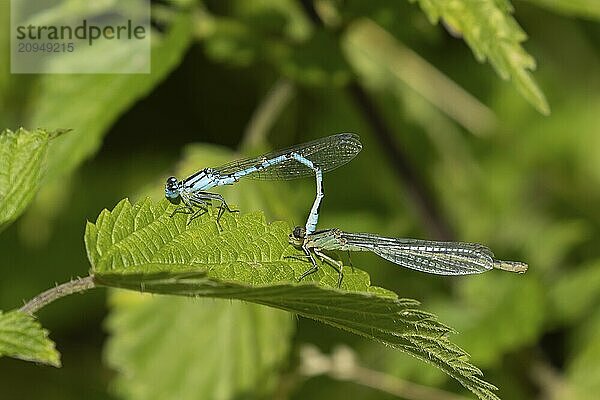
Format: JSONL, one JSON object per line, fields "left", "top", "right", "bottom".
{"left": 85, "top": 199, "right": 498, "bottom": 399}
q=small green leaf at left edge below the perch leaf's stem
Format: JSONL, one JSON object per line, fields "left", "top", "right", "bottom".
{"left": 0, "top": 311, "right": 60, "bottom": 367}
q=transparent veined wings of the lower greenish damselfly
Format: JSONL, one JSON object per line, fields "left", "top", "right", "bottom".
{"left": 341, "top": 232, "right": 496, "bottom": 275}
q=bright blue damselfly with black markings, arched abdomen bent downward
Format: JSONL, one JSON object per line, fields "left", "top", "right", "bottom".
{"left": 165, "top": 133, "right": 362, "bottom": 233}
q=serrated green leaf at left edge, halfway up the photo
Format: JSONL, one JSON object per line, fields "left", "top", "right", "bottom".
{"left": 0, "top": 128, "right": 63, "bottom": 231}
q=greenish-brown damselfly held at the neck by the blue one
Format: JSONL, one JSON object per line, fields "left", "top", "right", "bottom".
{"left": 289, "top": 226, "right": 527, "bottom": 286}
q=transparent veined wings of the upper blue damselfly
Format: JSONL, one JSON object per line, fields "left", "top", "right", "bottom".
{"left": 214, "top": 133, "right": 362, "bottom": 180}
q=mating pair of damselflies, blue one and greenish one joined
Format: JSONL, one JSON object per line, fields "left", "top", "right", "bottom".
{"left": 165, "top": 133, "right": 527, "bottom": 286}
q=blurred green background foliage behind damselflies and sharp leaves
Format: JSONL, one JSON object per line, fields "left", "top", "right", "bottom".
{"left": 0, "top": 0, "right": 600, "bottom": 400}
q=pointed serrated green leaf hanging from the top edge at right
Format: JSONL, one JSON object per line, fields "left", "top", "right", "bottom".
{"left": 411, "top": 0, "right": 550, "bottom": 115}
